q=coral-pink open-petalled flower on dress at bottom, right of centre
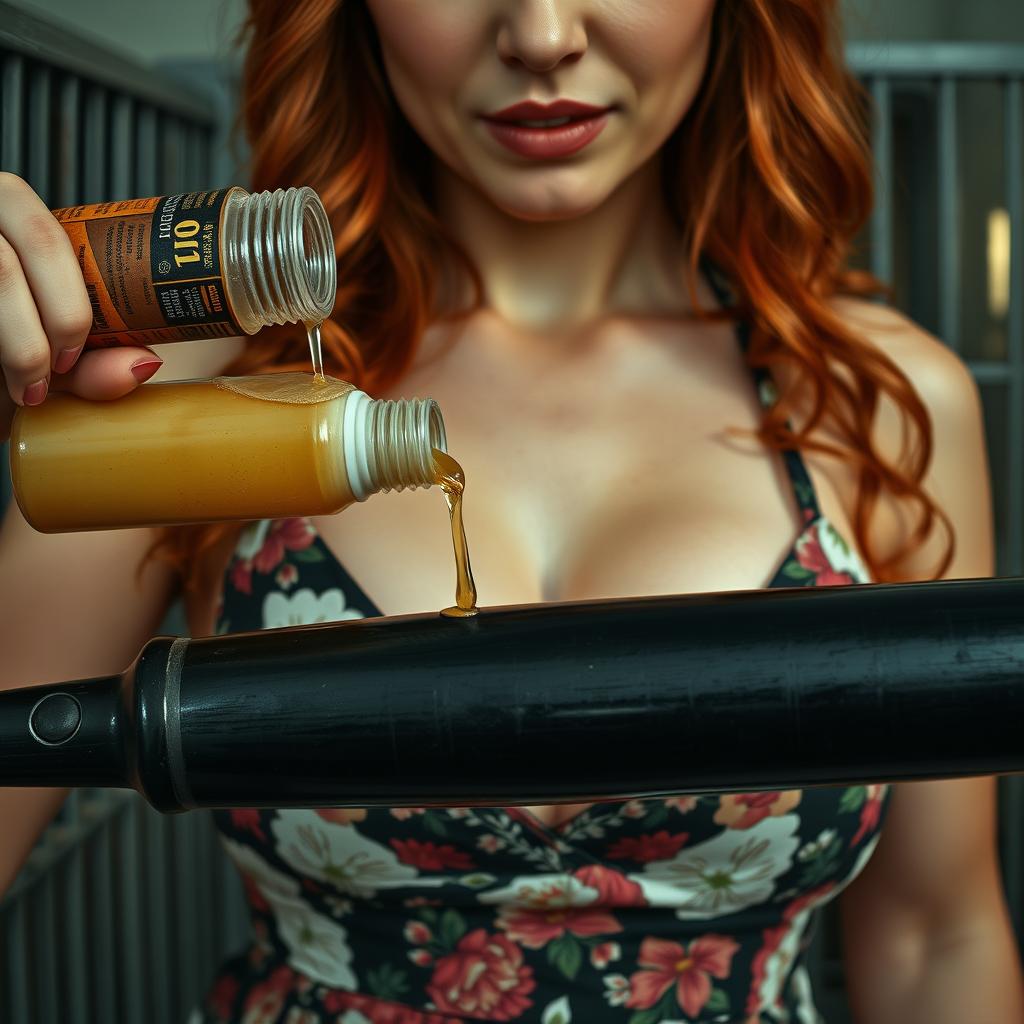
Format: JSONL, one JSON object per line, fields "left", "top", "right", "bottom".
{"left": 626, "top": 935, "right": 739, "bottom": 1017}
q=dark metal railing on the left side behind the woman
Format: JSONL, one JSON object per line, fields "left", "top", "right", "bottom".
{"left": 0, "top": 2, "right": 248, "bottom": 1024}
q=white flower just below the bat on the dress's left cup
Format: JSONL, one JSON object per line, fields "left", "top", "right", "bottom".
{"left": 270, "top": 809, "right": 446, "bottom": 899}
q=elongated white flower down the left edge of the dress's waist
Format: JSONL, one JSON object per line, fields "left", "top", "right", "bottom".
{"left": 220, "top": 836, "right": 356, "bottom": 989}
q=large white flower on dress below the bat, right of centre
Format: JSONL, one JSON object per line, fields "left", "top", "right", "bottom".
{"left": 628, "top": 814, "right": 800, "bottom": 921}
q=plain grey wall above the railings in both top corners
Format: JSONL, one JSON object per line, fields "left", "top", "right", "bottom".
{"left": 6, "top": 0, "right": 1024, "bottom": 61}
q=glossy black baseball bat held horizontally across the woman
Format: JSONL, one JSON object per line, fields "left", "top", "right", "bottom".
{"left": 0, "top": 578, "right": 1024, "bottom": 812}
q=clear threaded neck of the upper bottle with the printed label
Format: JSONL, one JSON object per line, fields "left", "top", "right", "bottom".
{"left": 223, "top": 186, "right": 337, "bottom": 334}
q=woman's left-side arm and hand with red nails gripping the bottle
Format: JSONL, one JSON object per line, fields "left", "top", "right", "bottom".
{"left": 0, "top": 172, "right": 244, "bottom": 896}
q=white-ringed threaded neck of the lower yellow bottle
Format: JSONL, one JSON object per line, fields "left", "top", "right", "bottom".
{"left": 343, "top": 391, "right": 447, "bottom": 501}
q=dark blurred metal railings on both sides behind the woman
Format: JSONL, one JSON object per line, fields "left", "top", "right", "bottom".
{"left": 0, "top": 9, "right": 1024, "bottom": 1024}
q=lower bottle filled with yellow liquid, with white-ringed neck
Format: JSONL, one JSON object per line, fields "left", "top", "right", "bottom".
{"left": 10, "top": 373, "right": 447, "bottom": 532}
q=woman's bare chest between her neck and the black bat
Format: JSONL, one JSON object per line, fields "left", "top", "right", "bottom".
{"left": 316, "top": 313, "right": 850, "bottom": 614}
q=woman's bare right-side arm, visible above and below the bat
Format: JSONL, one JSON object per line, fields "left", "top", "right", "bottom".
{"left": 840, "top": 311, "right": 1024, "bottom": 1024}
